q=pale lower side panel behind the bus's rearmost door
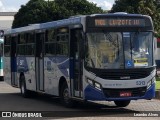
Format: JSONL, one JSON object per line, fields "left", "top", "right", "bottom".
{"left": 4, "top": 57, "right": 11, "bottom": 85}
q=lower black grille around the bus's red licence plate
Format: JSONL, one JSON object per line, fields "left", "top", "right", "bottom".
{"left": 103, "top": 87, "right": 146, "bottom": 98}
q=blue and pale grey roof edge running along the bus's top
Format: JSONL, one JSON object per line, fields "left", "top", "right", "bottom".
{"left": 4, "top": 12, "right": 151, "bottom": 35}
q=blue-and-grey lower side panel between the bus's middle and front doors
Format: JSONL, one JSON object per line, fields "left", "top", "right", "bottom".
{"left": 44, "top": 56, "right": 69, "bottom": 96}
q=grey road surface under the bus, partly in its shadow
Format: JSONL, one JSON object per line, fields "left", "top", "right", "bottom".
{"left": 0, "top": 82, "right": 160, "bottom": 120}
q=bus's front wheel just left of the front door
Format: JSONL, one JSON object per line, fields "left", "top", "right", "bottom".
{"left": 60, "top": 82, "right": 74, "bottom": 107}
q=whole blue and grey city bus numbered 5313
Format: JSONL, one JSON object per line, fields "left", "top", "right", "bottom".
{"left": 4, "top": 13, "right": 156, "bottom": 107}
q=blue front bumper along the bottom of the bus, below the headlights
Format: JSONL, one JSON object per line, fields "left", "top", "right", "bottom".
{"left": 84, "top": 83, "right": 155, "bottom": 101}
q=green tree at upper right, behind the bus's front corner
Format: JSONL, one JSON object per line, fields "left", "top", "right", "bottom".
{"left": 110, "top": 0, "right": 160, "bottom": 36}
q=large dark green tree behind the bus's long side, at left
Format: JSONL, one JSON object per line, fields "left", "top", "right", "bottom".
{"left": 12, "top": 0, "right": 103, "bottom": 28}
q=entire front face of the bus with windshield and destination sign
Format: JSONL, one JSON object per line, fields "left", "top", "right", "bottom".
{"left": 84, "top": 14, "right": 155, "bottom": 101}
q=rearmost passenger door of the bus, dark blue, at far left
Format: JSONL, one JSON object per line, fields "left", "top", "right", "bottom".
{"left": 11, "top": 35, "right": 18, "bottom": 86}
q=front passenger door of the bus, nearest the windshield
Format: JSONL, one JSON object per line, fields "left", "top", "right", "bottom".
{"left": 70, "top": 29, "right": 83, "bottom": 98}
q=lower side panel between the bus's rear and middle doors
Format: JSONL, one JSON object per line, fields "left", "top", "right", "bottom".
{"left": 17, "top": 57, "right": 36, "bottom": 91}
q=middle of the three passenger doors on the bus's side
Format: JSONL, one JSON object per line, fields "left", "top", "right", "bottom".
{"left": 35, "top": 32, "right": 45, "bottom": 91}
